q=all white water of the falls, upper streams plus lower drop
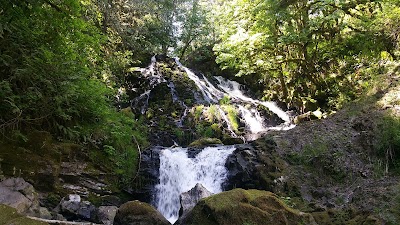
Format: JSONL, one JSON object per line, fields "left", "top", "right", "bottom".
{"left": 131, "top": 57, "right": 294, "bottom": 223}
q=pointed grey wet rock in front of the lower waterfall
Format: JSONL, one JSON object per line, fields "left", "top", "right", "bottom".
{"left": 179, "top": 183, "right": 213, "bottom": 216}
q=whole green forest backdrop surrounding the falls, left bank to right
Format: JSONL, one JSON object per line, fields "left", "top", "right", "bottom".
{"left": 0, "top": 0, "right": 400, "bottom": 193}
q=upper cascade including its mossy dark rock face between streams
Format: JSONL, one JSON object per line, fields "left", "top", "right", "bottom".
{"left": 123, "top": 55, "right": 294, "bottom": 145}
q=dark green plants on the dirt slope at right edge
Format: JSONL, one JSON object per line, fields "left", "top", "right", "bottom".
{"left": 376, "top": 116, "right": 400, "bottom": 173}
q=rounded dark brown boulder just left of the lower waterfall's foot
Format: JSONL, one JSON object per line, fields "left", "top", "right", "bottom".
{"left": 114, "top": 201, "right": 170, "bottom": 225}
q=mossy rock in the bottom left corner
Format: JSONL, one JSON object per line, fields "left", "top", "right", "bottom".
{"left": 0, "top": 204, "right": 48, "bottom": 225}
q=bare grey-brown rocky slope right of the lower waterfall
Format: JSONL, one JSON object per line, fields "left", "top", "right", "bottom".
{"left": 220, "top": 88, "right": 400, "bottom": 224}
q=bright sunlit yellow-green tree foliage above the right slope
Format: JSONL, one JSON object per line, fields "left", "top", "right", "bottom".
{"left": 214, "top": 0, "right": 400, "bottom": 111}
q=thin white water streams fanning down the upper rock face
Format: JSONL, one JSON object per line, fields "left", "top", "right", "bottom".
{"left": 131, "top": 56, "right": 295, "bottom": 140}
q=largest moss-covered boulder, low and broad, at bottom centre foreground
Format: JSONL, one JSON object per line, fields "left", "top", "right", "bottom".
{"left": 176, "top": 189, "right": 316, "bottom": 225}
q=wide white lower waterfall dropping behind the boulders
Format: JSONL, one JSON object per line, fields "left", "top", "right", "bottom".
{"left": 155, "top": 146, "right": 235, "bottom": 223}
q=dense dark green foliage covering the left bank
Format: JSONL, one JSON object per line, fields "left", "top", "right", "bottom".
{"left": 0, "top": 0, "right": 147, "bottom": 184}
